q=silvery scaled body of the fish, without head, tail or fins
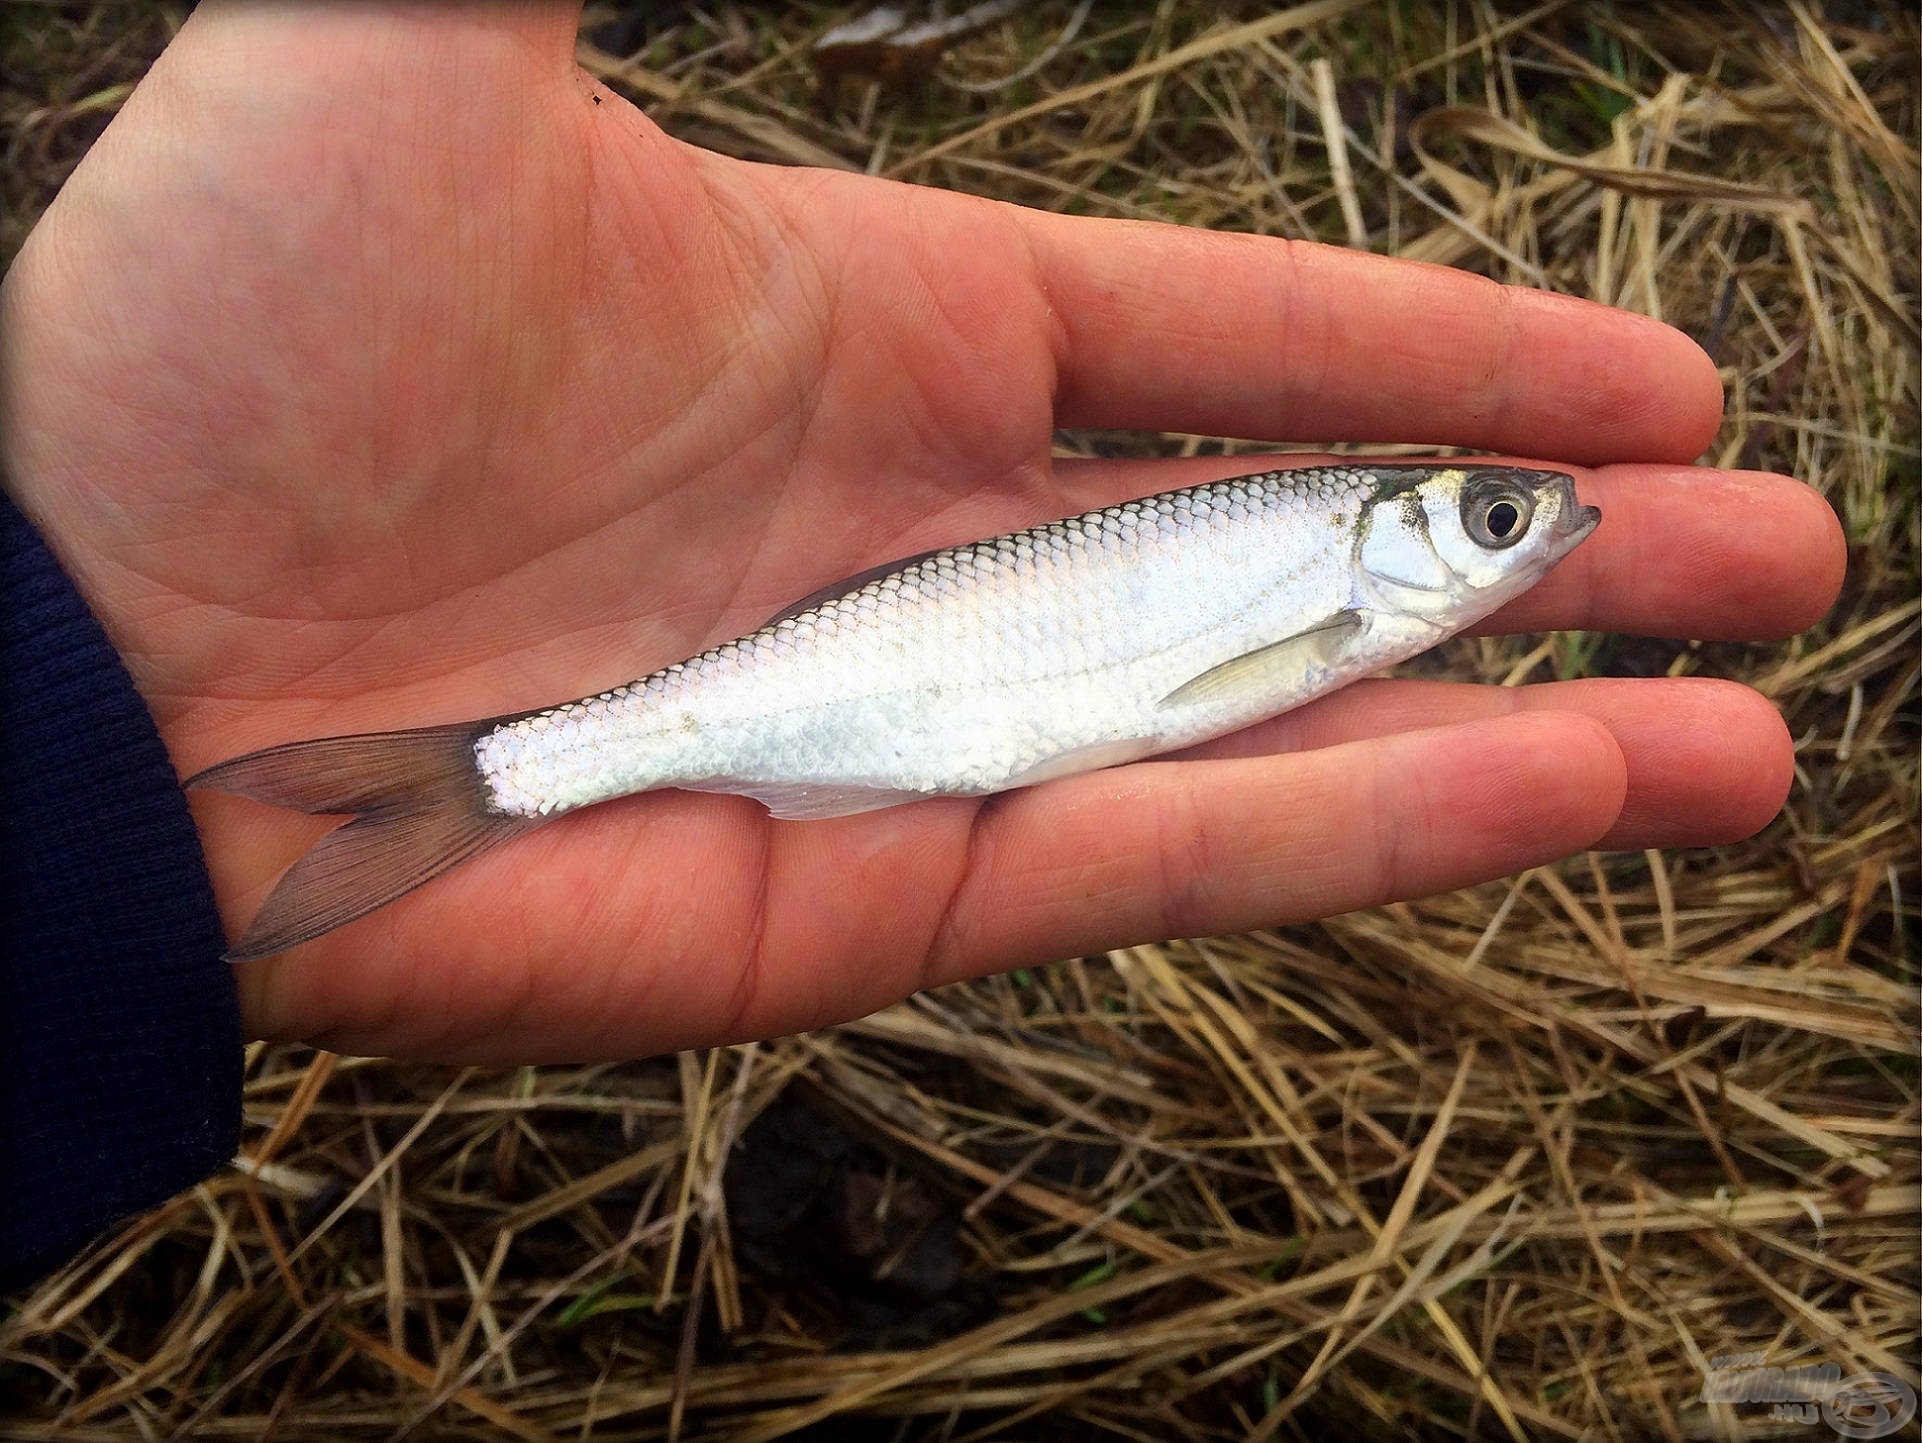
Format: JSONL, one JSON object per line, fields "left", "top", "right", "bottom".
{"left": 475, "top": 467, "right": 1414, "bottom": 817}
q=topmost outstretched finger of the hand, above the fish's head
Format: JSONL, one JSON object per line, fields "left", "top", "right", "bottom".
{"left": 1021, "top": 211, "right": 1722, "bottom": 465}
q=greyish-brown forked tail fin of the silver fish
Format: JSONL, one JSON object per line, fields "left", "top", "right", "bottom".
{"left": 186, "top": 721, "right": 542, "bottom": 963}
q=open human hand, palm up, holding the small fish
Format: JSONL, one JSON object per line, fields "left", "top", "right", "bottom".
{"left": 0, "top": 0, "right": 1841, "bottom": 1061}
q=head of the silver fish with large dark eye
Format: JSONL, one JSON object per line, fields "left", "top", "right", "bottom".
{"left": 1355, "top": 465, "right": 1601, "bottom": 630}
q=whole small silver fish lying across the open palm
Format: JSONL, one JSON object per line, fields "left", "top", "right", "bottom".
{"left": 188, "top": 461, "right": 1601, "bottom": 961}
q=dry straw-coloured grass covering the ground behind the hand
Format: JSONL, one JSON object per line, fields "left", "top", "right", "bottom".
{"left": 0, "top": 0, "right": 1922, "bottom": 1443}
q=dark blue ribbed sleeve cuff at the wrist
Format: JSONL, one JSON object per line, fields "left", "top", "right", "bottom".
{"left": 0, "top": 496, "right": 242, "bottom": 1291}
